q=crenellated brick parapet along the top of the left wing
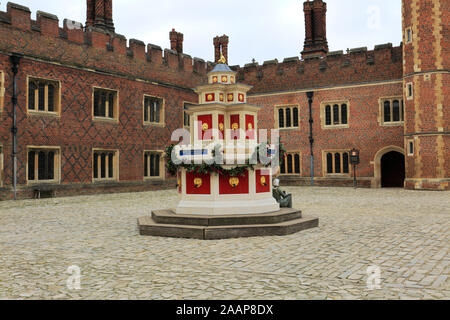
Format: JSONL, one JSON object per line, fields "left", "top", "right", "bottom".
{"left": 0, "top": 2, "right": 213, "bottom": 88}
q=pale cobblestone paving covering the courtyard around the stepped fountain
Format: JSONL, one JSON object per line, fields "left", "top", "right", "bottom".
{"left": 0, "top": 188, "right": 450, "bottom": 300}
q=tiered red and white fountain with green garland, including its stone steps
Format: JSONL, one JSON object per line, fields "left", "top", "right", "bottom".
{"left": 138, "top": 57, "right": 318, "bottom": 239}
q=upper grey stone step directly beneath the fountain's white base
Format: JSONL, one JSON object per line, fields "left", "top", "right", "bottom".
{"left": 152, "top": 208, "right": 302, "bottom": 227}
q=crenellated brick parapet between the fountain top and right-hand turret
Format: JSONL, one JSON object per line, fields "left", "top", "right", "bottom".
{"left": 231, "top": 43, "right": 402, "bottom": 93}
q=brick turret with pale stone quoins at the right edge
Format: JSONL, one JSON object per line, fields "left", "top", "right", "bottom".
{"left": 402, "top": 0, "right": 450, "bottom": 190}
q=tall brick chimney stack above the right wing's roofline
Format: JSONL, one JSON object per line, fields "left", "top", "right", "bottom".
{"left": 302, "top": 0, "right": 328, "bottom": 59}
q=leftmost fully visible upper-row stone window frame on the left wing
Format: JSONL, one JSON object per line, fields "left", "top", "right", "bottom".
{"left": 26, "top": 75, "right": 61, "bottom": 117}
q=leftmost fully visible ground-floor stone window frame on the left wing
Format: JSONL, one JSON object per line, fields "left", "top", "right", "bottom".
{"left": 26, "top": 145, "right": 61, "bottom": 186}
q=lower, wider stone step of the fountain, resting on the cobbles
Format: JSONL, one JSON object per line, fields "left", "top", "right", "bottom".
{"left": 138, "top": 217, "right": 319, "bottom": 240}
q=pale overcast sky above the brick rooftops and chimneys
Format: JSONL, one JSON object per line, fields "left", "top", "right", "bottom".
{"left": 5, "top": 0, "right": 401, "bottom": 65}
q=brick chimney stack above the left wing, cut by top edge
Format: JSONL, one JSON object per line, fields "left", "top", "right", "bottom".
{"left": 86, "top": 0, "right": 115, "bottom": 32}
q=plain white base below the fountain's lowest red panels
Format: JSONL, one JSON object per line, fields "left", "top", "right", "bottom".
{"left": 176, "top": 197, "right": 280, "bottom": 215}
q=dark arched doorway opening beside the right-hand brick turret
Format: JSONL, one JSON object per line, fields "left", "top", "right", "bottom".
{"left": 381, "top": 151, "right": 405, "bottom": 188}
